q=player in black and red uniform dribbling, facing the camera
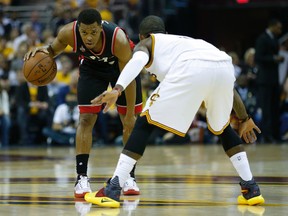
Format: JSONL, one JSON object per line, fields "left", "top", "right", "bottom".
{"left": 24, "top": 9, "right": 142, "bottom": 198}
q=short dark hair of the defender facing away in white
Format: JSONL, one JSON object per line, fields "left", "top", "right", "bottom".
{"left": 139, "top": 15, "right": 166, "bottom": 37}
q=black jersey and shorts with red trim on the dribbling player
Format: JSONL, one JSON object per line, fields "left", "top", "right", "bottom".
{"left": 73, "top": 21, "right": 142, "bottom": 115}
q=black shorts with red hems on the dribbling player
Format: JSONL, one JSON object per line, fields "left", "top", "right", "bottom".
{"left": 77, "top": 60, "right": 142, "bottom": 114}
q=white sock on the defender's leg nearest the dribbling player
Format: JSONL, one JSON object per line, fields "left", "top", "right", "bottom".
{"left": 112, "top": 153, "right": 137, "bottom": 188}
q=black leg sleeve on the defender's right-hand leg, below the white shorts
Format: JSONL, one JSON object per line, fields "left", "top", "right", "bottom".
{"left": 219, "top": 125, "right": 243, "bottom": 151}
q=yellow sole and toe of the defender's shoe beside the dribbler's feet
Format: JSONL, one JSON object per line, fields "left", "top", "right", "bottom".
{"left": 84, "top": 191, "right": 120, "bottom": 208}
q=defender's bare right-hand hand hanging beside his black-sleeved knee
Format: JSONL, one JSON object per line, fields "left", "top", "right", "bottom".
{"left": 238, "top": 118, "right": 261, "bottom": 143}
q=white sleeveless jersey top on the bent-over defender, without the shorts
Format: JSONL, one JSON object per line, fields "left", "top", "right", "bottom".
{"left": 145, "top": 34, "right": 231, "bottom": 81}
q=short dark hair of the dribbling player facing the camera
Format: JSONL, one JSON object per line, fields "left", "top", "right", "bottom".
{"left": 77, "top": 9, "right": 102, "bottom": 25}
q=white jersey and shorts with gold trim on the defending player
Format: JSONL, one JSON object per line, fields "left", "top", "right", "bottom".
{"left": 141, "top": 34, "right": 235, "bottom": 136}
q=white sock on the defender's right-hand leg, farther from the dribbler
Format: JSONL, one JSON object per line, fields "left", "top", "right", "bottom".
{"left": 230, "top": 152, "right": 253, "bottom": 181}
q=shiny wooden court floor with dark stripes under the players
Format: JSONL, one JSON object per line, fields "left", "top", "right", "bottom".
{"left": 0, "top": 144, "right": 288, "bottom": 216}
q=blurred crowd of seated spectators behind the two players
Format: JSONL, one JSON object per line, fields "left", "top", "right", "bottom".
{"left": 0, "top": 0, "right": 288, "bottom": 147}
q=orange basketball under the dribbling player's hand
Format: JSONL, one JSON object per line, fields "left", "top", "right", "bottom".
{"left": 23, "top": 52, "right": 57, "bottom": 86}
